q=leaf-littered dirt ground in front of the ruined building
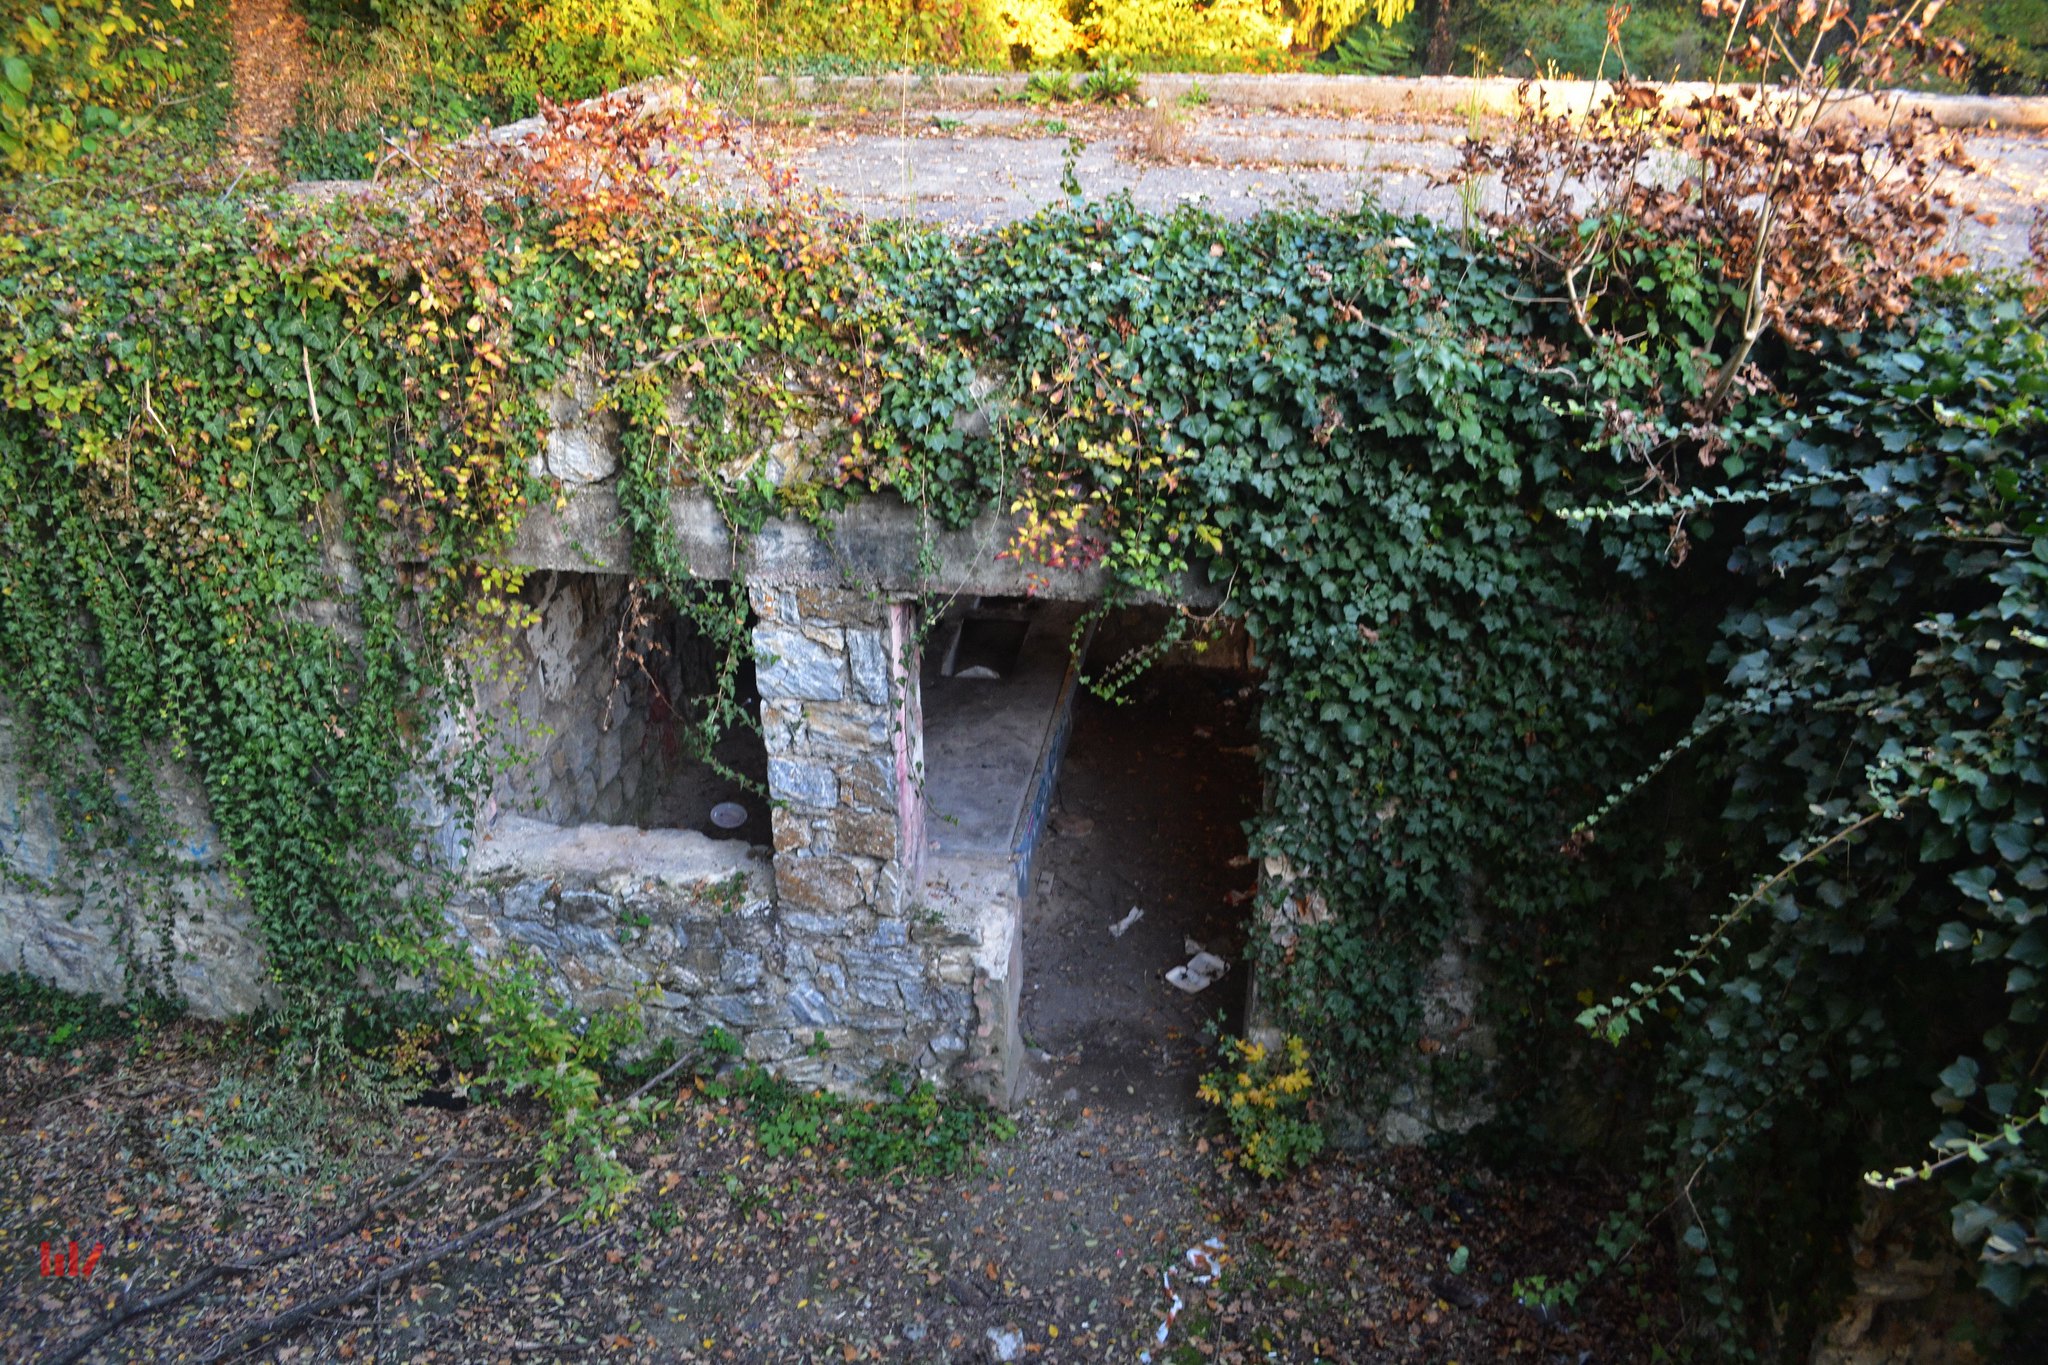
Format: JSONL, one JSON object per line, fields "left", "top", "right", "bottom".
{"left": 0, "top": 1025, "right": 1687, "bottom": 1365}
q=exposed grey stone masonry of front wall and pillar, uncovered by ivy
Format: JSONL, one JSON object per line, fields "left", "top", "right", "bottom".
{"left": 0, "top": 358, "right": 1040, "bottom": 1093}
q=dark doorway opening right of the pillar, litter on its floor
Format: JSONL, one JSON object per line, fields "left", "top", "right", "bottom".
{"left": 1022, "top": 614, "right": 1260, "bottom": 1111}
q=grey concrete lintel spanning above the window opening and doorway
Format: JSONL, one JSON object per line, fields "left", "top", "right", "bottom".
{"left": 506, "top": 487, "right": 1223, "bottom": 606}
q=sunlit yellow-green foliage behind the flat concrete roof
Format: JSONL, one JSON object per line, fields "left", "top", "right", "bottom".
{"left": 285, "top": 0, "right": 2048, "bottom": 178}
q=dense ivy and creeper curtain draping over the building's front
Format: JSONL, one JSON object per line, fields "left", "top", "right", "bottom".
{"left": 0, "top": 4, "right": 2048, "bottom": 1355}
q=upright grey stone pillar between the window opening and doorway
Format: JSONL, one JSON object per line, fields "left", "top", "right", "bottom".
{"left": 748, "top": 585, "right": 924, "bottom": 919}
